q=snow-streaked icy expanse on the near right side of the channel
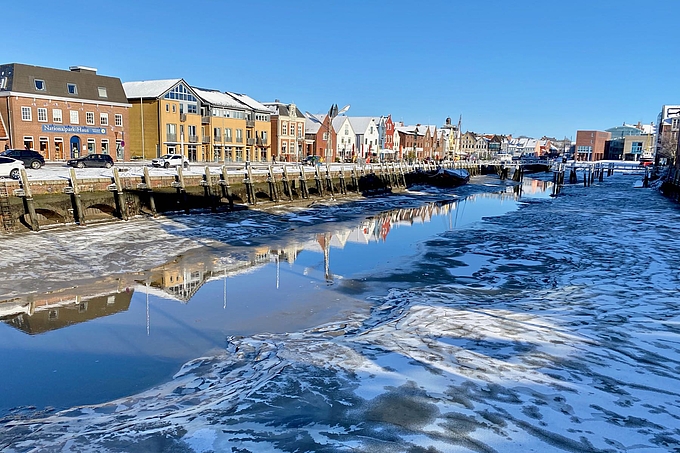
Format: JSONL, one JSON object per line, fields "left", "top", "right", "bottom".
{"left": 0, "top": 176, "right": 680, "bottom": 453}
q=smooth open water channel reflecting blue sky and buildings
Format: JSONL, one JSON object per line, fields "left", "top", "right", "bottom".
{"left": 0, "top": 179, "right": 551, "bottom": 414}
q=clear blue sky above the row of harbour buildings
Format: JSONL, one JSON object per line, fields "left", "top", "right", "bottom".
{"left": 6, "top": 0, "right": 680, "bottom": 138}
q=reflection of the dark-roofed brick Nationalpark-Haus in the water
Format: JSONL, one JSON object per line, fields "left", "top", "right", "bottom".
{"left": 0, "top": 280, "right": 134, "bottom": 335}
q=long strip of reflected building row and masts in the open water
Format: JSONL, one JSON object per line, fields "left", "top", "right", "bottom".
{"left": 0, "top": 180, "right": 552, "bottom": 334}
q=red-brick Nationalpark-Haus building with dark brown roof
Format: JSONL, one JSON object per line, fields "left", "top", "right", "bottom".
{"left": 0, "top": 63, "right": 130, "bottom": 161}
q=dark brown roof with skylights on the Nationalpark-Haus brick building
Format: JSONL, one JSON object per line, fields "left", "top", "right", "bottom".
{"left": 0, "top": 63, "right": 128, "bottom": 104}
